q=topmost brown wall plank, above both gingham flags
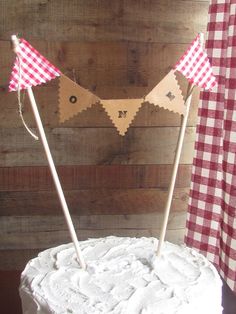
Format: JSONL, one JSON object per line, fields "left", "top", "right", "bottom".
{"left": 0, "top": 0, "right": 208, "bottom": 42}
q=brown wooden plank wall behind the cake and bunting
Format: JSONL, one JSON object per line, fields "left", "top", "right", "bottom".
{"left": 0, "top": 0, "right": 209, "bottom": 269}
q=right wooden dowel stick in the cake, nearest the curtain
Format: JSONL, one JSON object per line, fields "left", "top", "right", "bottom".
{"left": 157, "top": 85, "right": 193, "bottom": 256}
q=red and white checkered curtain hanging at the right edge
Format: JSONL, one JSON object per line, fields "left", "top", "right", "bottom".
{"left": 185, "top": 0, "right": 236, "bottom": 293}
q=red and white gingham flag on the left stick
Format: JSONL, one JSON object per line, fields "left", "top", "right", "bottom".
{"left": 9, "top": 39, "right": 61, "bottom": 91}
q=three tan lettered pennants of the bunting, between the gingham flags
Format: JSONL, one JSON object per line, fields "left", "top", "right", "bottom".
{"left": 59, "top": 70, "right": 185, "bottom": 135}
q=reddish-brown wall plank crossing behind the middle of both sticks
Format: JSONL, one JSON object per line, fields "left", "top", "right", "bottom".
{"left": 0, "top": 165, "right": 191, "bottom": 192}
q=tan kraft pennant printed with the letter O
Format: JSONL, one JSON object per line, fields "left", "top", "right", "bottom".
{"left": 59, "top": 75, "right": 100, "bottom": 123}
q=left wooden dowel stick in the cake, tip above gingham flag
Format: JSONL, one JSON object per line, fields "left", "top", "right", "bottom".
{"left": 12, "top": 35, "right": 86, "bottom": 269}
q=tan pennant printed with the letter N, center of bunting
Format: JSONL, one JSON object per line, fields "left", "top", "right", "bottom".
{"left": 101, "top": 99, "right": 143, "bottom": 135}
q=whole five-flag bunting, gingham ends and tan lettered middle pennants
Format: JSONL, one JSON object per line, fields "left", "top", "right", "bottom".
{"left": 9, "top": 35, "right": 216, "bottom": 135}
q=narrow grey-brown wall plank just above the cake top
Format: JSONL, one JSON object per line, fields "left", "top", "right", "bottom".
{"left": 0, "top": 211, "right": 186, "bottom": 234}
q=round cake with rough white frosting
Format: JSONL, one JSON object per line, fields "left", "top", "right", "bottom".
{"left": 20, "top": 236, "right": 222, "bottom": 314}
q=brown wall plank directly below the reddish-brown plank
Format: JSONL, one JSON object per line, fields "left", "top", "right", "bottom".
{"left": 0, "top": 188, "right": 189, "bottom": 216}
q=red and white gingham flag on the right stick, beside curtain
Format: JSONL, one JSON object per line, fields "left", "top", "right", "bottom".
{"left": 175, "top": 34, "right": 216, "bottom": 90}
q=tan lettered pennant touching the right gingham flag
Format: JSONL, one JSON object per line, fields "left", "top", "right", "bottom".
{"left": 145, "top": 70, "right": 185, "bottom": 114}
